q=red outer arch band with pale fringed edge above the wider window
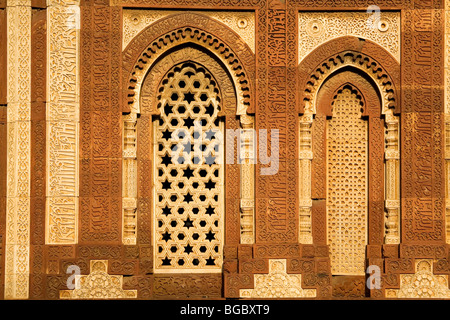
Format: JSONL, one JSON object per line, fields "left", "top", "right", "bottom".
{"left": 123, "top": 12, "right": 255, "bottom": 115}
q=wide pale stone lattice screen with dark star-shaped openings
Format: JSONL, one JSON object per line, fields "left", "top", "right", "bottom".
{"left": 154, "top": 63, "right": 224, "bottom": 272}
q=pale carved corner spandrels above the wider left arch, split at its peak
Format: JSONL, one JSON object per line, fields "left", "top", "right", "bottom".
{"left": 123, "top": 9, "right": 255, "bottom": 52}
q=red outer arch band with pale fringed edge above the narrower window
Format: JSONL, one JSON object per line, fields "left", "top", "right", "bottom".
{"left": 298, "top": 36, "right": 401, "bottom": 114}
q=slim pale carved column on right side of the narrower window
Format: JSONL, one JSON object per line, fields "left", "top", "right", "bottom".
{"left": 385, "top": 110, "right": 400, "bottom": 244}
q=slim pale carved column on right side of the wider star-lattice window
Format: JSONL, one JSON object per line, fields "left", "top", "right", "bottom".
{"left": 240, "top": 115, "right": 256, "bottom": 244}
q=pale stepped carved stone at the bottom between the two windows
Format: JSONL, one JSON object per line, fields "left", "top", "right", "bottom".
{"left": 240, "top": 259, "right": 317, "bottom": 299}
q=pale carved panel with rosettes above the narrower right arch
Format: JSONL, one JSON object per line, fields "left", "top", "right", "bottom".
{"left": 298, "top": 12, "right": 400, "bottom": 62}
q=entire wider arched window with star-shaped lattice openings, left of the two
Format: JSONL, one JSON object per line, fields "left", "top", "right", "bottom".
{"left": 122, "top": 13, "right": 255, "bottom": 275}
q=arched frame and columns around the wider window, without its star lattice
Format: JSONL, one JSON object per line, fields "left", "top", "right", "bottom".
{"left": 123, "top": 16, "right": 254, "bottom": 260}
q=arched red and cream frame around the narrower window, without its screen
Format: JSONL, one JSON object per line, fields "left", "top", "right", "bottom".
{"left": 298, "top": 37, "right": 401, "bottom": 254}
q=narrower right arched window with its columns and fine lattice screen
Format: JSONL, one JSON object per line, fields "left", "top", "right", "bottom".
{"left": 299, "top": 43, "right": 400, "bottom": 276}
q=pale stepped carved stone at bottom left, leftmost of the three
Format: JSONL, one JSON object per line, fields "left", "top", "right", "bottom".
{"left": 60, "top": 260, "right": 137, "bottom": 300}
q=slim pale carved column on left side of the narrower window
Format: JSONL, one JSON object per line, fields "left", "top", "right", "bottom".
{"left": 298, "top": 114, "right": 313, "bottom": 244}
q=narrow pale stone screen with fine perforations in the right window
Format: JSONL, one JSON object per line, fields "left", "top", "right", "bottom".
{"left": 327, "top": 87, "right": 368, "bottom": 275}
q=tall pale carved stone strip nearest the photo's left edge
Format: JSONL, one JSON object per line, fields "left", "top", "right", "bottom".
{"left": 5, "top": 2, "right": 31, "bottom": 299}
